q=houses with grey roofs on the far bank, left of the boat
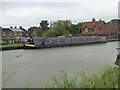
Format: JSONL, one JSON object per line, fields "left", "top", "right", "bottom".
{"left": 0, "top": 26, "right": 27, "bottom": 43}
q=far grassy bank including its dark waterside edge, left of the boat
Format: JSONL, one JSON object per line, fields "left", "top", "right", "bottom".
{"left": 0, "top": 43, "right": 23, "bottom": 50}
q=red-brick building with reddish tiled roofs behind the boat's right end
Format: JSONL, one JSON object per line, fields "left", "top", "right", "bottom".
{"left": 80, "top": 18, "right": 119, "bottom": 38}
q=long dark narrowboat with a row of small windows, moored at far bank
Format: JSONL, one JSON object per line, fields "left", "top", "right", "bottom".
{"left": 24, "top": 36, "right": 108, "bottom": 49}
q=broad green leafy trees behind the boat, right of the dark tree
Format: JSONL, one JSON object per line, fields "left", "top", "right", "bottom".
{"left": 41, "top": 20, "right": 82, "bottom": 37}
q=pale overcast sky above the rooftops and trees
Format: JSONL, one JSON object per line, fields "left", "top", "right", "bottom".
{"left": 0, "top": 0, "right": 119, "bottom": 29}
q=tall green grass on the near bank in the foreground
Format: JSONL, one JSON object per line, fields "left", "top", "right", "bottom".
{"left": 46, "top": 66, "right": 119, "bottom": 88}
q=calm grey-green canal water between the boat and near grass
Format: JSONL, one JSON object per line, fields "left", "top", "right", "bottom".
{"left": 2, "top": 42, "right": 118, "bottom": 88}
